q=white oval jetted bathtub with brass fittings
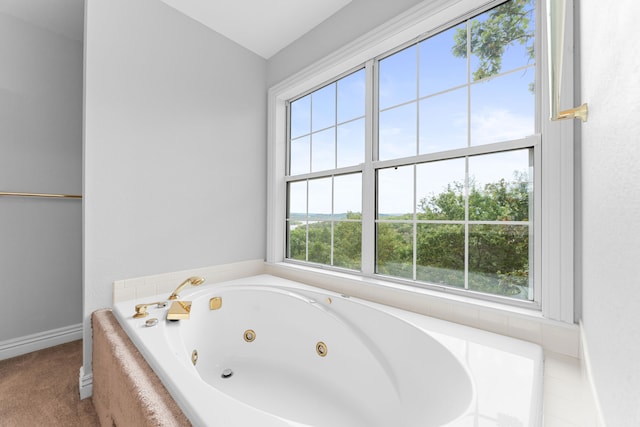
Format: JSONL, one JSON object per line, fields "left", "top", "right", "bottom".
{"left": 113, "top": 275, "right": 543, "bottom": 427}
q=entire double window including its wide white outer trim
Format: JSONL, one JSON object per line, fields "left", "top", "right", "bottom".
{"left": 268, "top": 0, "right": 573, "bottom": 321}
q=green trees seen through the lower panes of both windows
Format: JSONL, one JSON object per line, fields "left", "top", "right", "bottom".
{"left": 289, "top": 173, "right": 530, "bottom": 299}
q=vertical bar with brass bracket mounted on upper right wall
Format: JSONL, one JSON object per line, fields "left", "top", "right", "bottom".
{"left": 547, "top": 0, "right": 589, "bottom": 122}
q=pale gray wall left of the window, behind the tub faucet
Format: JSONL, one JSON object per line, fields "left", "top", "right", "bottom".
{"left": 84, "top": 0, "right": 266, "bottom": 382}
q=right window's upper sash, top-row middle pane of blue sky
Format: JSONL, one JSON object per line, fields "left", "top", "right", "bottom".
{"left": 419, "top": 23, "right": 467, "bottom": 97}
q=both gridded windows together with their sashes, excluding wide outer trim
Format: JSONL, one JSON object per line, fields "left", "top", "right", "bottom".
{"left": 286, "top": 0, "right": 538, "bottom": 301}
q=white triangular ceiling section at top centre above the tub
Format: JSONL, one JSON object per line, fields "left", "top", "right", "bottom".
{"left": 162, "top": 0, "right": 351, "bottom": 59}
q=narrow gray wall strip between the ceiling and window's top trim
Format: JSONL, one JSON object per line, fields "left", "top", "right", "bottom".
{"left": 267, "top": 0, "right": 421, "bottom": 86}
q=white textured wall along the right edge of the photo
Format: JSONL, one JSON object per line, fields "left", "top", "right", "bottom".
{"left": 579, "top": 0, "right": 640, "bottom": 427}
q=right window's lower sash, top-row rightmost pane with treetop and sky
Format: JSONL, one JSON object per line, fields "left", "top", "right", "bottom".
{"left": 469, "top": 150, "right": 533, "bottom": 221}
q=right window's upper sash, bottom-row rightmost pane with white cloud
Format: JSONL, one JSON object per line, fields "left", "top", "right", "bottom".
{"left": 471, "top": 68, "right": 535, "bottom": 145}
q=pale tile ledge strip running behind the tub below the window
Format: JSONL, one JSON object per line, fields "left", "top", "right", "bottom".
{"left": 113, "top": 260, "right": 580, "bottom": 358}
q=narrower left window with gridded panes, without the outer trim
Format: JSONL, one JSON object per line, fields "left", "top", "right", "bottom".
{"left": 286, "top": 70, "right": 365, "bottom": 270}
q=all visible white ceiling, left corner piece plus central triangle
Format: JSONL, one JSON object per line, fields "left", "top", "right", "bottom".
{"left": 0, "top": 0, "right": 352, "bottom": 59}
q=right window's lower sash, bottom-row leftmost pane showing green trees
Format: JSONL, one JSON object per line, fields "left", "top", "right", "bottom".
{"left": 376, "top": 223, "right": 413, "bottom": 279}
